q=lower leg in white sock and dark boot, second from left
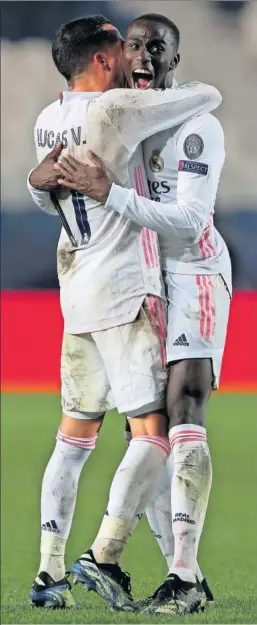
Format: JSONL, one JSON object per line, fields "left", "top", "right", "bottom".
{"left": 72, "top": 413, "right": 170, "bottom": 610}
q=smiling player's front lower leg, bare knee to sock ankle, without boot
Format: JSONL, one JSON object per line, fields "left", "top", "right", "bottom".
{"left": 168, "top": 359, "right": 212, "bottom": 583}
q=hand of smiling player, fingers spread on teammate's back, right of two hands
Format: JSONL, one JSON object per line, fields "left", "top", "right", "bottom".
{"left": 54, "top": 151, "right": 112, "bottom": 204}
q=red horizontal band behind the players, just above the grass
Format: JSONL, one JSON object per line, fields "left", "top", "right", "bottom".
{"left": 1, "top": 291, "right": 257, "bottom": 393}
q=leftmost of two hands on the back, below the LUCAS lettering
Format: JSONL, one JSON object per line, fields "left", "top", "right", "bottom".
{"left": 29, "top": 142, "right": 62, "bottom": 191}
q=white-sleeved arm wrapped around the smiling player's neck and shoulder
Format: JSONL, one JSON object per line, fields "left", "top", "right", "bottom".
{"left": 93, "top": 83, "right": 222, "bottom": 150}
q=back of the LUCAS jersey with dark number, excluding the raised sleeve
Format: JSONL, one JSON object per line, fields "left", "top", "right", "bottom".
{"left": 35, "top": 92, "right": 163, "bottom": 333}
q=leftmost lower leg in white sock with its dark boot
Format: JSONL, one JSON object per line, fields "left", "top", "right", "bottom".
{"left": 30, "top": 417, "right": 101, "bottom": 608}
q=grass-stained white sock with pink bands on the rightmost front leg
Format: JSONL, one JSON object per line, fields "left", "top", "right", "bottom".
{"left": 169, "top": 424, "right": 212, "bottom": 582}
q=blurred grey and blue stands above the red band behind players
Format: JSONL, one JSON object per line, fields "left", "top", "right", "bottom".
{"left": 1, "top": 0, "right": 257, "bottom": 390}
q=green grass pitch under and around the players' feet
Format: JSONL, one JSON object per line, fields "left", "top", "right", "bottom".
{"left": 2, "top": 395, "right": 257, "bottom": 623}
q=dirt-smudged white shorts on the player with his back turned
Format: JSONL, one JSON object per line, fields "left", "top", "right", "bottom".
{"left": 61, "top": 297, "right": 167, "bottom": 419}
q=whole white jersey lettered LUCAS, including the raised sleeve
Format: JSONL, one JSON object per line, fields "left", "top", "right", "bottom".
{"left": 29, "top": 83, "right": 221, "bottom": 334}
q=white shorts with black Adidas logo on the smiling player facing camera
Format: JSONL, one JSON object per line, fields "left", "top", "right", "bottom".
{"left": 164, "top": 271, "right": 230, "bottom": 389}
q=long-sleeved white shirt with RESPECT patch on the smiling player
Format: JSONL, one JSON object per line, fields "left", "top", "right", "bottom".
{"left": 106, "top": 114, "right": 232, "bottom": 291}
